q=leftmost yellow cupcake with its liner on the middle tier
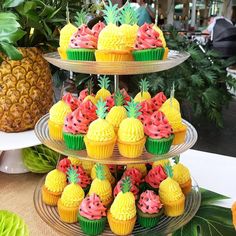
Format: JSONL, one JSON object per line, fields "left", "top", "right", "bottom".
{"left": 48, "top": 100, "right": 71, "bottom": 140}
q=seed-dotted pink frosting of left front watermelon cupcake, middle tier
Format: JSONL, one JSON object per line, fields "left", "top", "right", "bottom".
{"left": 63, "top": 108, "right": 91, "bottom": 134}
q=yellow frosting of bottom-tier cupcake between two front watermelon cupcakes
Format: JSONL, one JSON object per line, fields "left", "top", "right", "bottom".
{"left": 110, "top": 192, "right": 136, "bottom": 220}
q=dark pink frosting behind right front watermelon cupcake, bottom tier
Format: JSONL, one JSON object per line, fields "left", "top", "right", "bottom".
{"left": 145, "top": 166, "right": 167, "bottom": 188}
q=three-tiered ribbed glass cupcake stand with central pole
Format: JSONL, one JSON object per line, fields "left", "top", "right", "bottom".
{"left": 34, "top": 50, "right": 201, "bottom": 236}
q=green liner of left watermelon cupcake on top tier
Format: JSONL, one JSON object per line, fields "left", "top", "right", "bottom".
{"left": 66, "top": 48, "right": 95, "bottom": 61}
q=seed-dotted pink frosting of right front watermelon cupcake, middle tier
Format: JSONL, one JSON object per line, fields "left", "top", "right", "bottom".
{"left": 144, "top": 111, "right": 172, "bottom": 139}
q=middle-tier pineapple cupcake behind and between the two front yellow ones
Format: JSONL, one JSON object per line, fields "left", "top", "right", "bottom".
{"left": 106, "top": 91, "right": 127, "bottom": 133}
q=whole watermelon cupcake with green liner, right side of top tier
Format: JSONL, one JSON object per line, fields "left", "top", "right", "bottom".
{"left": 132, "top": 23, "right": 165, "bottom": 61}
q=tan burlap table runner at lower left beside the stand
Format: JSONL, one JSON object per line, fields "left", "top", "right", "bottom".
{"left": 0, "top": 172, "right": 61, "bottom": 236}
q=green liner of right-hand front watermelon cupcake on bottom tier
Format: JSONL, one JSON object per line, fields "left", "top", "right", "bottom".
{"left": 138, "top": 209, "right": 163, "bottom": 228}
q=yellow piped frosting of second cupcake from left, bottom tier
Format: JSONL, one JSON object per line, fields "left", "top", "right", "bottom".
{"left": 61, "top": 183, "right": 84, "bottom": 207}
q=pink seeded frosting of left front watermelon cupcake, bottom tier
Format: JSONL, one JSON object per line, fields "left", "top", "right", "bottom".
{"left": 79, "top": 193, "right": 107, "bottom": 220}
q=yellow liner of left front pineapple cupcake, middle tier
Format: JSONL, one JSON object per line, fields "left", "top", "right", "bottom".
{"left": 84, "top": 135, "right": 116, "bottom": 159}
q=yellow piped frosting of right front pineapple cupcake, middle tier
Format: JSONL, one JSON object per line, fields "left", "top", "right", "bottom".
{"left": 118, "top": 117, "right": 144, "bottom": 142}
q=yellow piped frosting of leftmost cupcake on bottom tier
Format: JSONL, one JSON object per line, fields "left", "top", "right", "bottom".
{"left": 45, "top": 169, "right": 67, "bottom": 193}
